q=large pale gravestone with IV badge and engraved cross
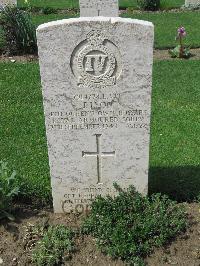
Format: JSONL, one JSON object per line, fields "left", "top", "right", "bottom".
{"left": 37, "top": 17, "right": 153, "bottom": 213}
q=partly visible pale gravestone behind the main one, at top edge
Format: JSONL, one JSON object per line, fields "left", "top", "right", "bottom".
{"left": 79, "top": 0, "right": 119, "bottom": 17}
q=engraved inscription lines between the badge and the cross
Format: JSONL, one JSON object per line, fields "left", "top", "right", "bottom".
{"left": 48, "top": 93, "right": 149, "bottom": 130}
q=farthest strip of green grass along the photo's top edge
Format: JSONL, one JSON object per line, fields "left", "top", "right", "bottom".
{"left": 18, "top": 0, "right": 184, "bottom": 9}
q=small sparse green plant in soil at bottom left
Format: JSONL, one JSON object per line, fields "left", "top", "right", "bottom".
{"left": 32, "top": 225, "right": 74, "bottom": 266}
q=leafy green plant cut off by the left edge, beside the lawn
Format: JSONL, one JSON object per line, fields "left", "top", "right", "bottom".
{"left": 0, "top": 161, "right": 19, "bottom": 220}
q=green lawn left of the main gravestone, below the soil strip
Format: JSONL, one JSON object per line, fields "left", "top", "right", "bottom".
{"left": 0, "top": 64, "right": 49, "bottom": 203}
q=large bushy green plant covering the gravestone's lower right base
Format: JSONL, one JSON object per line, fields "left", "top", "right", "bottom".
{"left": 82, "top": 184, "right": 187, "bottom": 265}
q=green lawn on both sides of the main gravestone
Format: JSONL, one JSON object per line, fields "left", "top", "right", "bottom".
{"left": 0, "top": 60, "right": 200, "bottom": 202}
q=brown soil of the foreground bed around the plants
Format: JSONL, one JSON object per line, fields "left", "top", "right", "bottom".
{"left": 0, "top": 203, "right": 200, "bottom": 266}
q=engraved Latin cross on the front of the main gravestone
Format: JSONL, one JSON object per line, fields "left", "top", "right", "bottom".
{"left": 82, "top": 134, "right": 115, "bottom": 184}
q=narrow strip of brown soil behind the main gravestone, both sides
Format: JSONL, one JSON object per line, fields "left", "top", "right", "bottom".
{"left": 0, "top": 48, "right": 200, "bottom": 63}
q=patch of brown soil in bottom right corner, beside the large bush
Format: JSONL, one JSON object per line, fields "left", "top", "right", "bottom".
{"left": 146, "top": 203, "right": 200, "bottom": 266}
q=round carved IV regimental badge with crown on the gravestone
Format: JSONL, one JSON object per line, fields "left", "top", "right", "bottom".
{"left": 71, "top": 30, "right": 121, "bottom": 88}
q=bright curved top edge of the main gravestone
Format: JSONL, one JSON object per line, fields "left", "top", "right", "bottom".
{"left": 37, "top": 17, "right": 154, "bottom": 32}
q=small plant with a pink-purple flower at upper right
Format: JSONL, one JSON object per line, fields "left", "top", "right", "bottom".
{"left": 169, "top": 27, "right": 191, "bottom": 58}
